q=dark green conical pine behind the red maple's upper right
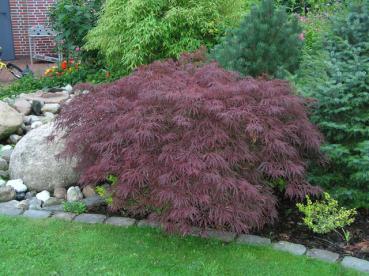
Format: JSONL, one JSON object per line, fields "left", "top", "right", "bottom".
{"left": 211, "top": 0, "right": 303, "bottom": 77}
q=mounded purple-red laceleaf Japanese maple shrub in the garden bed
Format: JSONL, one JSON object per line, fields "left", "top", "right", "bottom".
{"left": 57, "top": 52, "right": 321, "bottom": 233}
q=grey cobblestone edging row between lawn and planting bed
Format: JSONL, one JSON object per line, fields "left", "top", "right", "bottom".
{"left": 0, "top": 207, "right": 369, "bottom": 274}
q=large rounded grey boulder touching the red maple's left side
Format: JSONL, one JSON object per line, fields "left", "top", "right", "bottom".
{"left": 9, "top": 124, "right": 78, "bottom": 192}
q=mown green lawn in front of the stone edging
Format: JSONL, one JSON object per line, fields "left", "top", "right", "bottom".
{"left": 0, "top": 216, "right": 359, "bottom": 276}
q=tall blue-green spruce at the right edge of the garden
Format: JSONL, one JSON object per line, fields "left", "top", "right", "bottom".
{"left": 312, "top": 1, "right": 369, "bottom": 208}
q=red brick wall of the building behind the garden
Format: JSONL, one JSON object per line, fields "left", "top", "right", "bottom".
{"left": 8, "top": 0, "right": 56, "bottom": 57}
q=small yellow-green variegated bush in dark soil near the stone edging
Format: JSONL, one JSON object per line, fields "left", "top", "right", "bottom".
{"left": 296, "top": 193, "right": 356, "bottom": 234}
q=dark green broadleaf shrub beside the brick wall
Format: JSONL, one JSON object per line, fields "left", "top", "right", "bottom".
{"left": 50, "top": 0, "right": 105, "bottom": 62}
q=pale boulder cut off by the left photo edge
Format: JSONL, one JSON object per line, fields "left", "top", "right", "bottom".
{"left": 0, "top": 101, "right": 23, "bottom": 140}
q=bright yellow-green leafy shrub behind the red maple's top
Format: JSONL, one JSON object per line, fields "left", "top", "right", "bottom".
{"left": 85, "top": 0, "right": 249, "bottom": 73}
